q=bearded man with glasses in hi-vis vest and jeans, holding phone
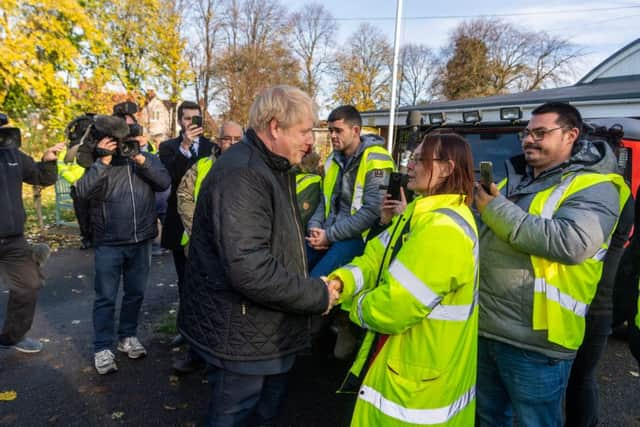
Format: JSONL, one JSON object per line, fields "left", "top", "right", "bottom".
{"left": 475, "top": 102, "right": 630, "bottom": 427}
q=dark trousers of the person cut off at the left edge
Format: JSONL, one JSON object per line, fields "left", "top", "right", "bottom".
{"left": 0, "top": 236, "right": 43, "bottom": 345}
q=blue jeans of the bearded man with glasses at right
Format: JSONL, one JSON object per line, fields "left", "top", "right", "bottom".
{"left": 476, "top": 337, "right": 573, "bottom": 427}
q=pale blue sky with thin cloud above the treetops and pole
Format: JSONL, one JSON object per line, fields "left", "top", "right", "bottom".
{"left": 283, "top": 0, "right": 640, "bottom": 83}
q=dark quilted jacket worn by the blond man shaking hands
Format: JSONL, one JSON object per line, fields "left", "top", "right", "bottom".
{"left": 178, "top": 129, "right": 329, "bottom": 361}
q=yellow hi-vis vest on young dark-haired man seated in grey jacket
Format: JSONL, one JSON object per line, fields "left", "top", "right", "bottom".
{"left": 322, "top": 145, "right": 395, "bottom": 237}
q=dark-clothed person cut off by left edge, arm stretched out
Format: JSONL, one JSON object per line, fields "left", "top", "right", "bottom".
{"left": 0, "top": 114, "right": 65, "bottom": 353}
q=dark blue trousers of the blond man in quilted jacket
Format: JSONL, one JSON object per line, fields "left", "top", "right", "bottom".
{"left": 205, "top": 366, "right": 289, "bottom": 427}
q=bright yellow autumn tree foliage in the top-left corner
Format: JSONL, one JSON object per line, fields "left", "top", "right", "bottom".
{"left": 0, "top": 0, "right": 95, "bottom": 138}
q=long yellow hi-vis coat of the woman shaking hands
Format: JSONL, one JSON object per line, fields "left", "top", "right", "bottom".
{"left": 330, "top": 194, "right": 478, "bottom": 427}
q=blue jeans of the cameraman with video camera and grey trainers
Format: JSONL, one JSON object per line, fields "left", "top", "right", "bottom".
{"left": 93, "top": 240, "right": 151, "bottom": 353}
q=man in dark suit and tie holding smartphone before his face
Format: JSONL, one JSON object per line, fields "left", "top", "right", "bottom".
{"left": 159, "top": 101, "right": 217, "bottom": 352}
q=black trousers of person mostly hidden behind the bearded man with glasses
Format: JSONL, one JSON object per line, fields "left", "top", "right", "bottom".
{"left": 565, "top": 315, "right": 611, "bottom": 427}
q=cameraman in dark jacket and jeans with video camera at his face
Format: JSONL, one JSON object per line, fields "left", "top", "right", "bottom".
{"left": 76, "top": 116, "right": 171, "bottom": 374}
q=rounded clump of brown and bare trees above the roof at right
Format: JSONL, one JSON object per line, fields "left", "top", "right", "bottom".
{"left": 436, "top": 18, "right": 582, "bottom": 99}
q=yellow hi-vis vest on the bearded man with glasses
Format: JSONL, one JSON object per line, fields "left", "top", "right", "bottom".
{"left": 499, "top": 173, "right": 630, "bottom": 350}
